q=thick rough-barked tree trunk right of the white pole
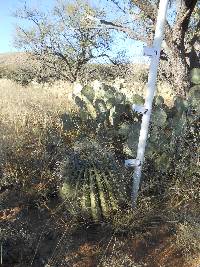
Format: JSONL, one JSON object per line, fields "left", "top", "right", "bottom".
{"left": 162, "top": 0, "right": 197, "bottom": 97}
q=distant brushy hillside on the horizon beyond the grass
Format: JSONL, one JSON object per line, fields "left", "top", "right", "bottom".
{"left": 0, "top": 52, "right": 148, "bottom": 84}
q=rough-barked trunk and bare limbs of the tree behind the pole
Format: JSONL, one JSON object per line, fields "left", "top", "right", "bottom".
{"left": 105, "top": 0, "right": 200, "bottom": 97}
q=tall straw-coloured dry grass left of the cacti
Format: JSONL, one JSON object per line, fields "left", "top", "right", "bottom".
{"left": 0, "top": 79, "right": 77, "bottom": 198}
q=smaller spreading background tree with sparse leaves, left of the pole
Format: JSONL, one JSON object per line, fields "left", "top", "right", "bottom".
{"left": 14, "top": 0, "right": 112, "bottom": 82}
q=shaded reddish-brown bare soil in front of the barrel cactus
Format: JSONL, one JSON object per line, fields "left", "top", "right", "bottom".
{"left": 0, "top": 188, "right": 200, "bottom": 267}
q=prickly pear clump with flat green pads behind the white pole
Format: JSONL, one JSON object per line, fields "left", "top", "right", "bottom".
{"left": 64, "top": 84, "right": 199, "bottom": 172}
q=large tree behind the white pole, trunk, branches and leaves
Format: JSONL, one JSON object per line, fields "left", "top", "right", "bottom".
{"left": 101, "top": 0, "right": 200, "bottom": 96}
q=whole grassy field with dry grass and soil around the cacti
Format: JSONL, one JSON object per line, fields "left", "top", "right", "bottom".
{"left": 0, "top": 79, "right": 200, "bottom": 267}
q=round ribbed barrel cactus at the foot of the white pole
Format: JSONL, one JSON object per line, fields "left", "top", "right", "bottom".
{"left": 60, "top": 138, "right": 126, "bottom": 221}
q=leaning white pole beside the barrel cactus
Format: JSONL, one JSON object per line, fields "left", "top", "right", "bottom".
{"left": 132, "top": 0, "right": 169, "bottom": 207}
